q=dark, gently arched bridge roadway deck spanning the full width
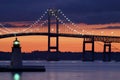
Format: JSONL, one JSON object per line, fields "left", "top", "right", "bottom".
{"left": 0, "top": 32, "right": 120, "bottom": 43}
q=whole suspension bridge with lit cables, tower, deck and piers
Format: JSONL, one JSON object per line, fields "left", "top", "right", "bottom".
{"left": 0, "top": 9, "right": 120, "bottom": 60}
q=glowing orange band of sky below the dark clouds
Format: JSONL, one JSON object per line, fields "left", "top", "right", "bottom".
{"left": 0, "top": 21, "right": 120, "bottom": 52}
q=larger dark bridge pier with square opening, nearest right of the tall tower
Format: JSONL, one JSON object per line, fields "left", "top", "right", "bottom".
{"left": 82, "top": 37, "right": 94, "bottom": 61}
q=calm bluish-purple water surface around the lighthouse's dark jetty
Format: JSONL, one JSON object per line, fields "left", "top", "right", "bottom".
{"left": 0, "top": 61, "right": 120, "bottom": 80}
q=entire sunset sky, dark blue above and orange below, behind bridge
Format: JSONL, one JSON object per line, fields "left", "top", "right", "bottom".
{"left": 0, "top": 0, "right": 120, "bottom": 52}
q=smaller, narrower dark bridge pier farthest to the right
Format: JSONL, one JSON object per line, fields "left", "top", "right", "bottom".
{"left": 103, "top": 42, "right": 111, "bottom": 61}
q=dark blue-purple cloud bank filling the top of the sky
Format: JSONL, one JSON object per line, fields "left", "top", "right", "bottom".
{"left": 0, "top": 0, "right": 120, "bottom": 24}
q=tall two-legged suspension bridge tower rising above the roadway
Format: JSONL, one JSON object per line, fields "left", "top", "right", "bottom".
{"left": 48, "top": 9, "right": 59, "bottom": 52}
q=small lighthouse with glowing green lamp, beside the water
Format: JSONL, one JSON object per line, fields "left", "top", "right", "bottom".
{"left": 11, "top": 38, "right": 22, "bottom": 68}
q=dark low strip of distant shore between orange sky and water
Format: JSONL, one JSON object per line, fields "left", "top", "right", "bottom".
{"left": 0, "top": 51, "right": 120, "bottom": 61}
